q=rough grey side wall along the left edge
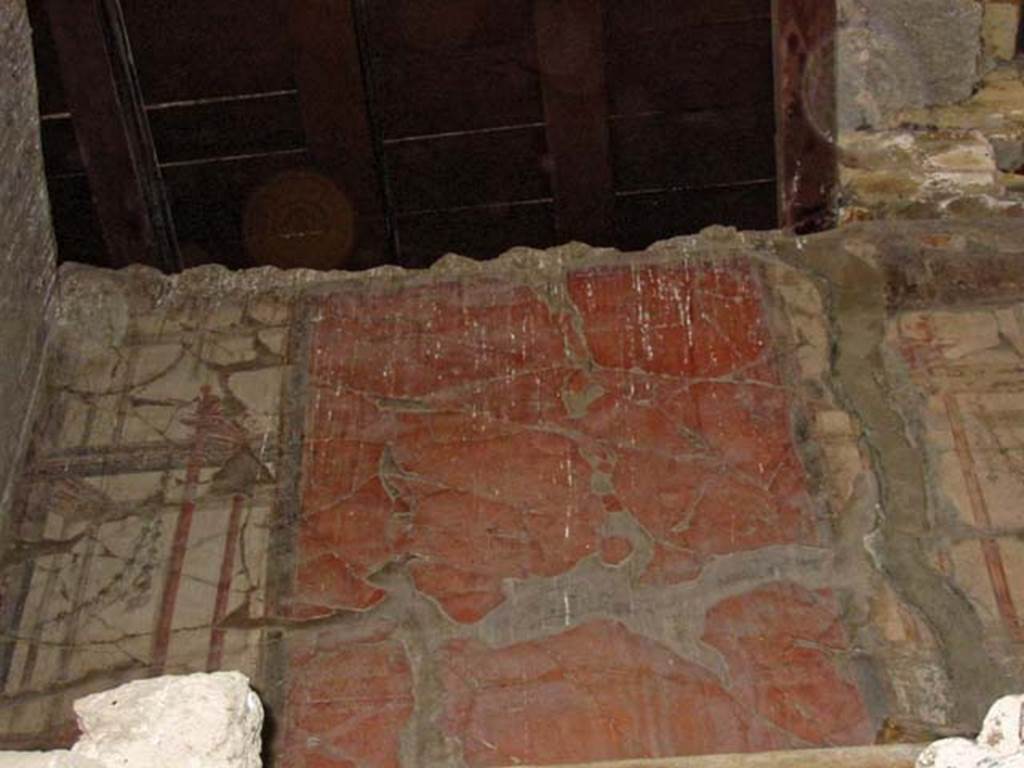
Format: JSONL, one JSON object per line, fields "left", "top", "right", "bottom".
{"left": 0, "top": 0, "right": 54, "bottom": 519}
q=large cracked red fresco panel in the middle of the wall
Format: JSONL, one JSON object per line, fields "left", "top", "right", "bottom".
{"left": 289, "top": 262, "right": 871, "bottom": 767}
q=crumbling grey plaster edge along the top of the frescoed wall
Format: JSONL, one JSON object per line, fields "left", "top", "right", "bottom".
{"left": 51, "top": 216, "right": 1024, "bottom": 326}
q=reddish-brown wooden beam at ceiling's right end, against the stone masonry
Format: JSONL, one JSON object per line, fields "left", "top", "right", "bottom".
{"left": 772, "top": 0, "right": 839, "bottom": 232}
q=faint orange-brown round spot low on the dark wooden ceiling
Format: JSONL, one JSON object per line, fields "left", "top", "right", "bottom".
{"left": 243, "top": 170, "right": 355, "bottom": 269}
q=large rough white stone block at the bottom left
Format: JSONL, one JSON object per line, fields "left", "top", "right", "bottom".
{"left": 73, "top": 672, "right": 263, "bottom": 768}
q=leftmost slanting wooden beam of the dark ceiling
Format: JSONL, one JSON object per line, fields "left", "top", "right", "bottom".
{"left": 46, "top": 0, "right": 181, "bottom": 271}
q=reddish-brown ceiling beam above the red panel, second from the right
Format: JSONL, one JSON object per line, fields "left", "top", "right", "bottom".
{"left": 534, "top": 0, "right": 614, "bottom": 245}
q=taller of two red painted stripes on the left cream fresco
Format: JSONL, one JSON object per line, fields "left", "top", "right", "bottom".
{"left": 150, "top": 386, "right": 217, "bottom": 673}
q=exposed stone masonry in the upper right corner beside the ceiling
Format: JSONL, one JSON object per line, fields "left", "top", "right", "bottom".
{"left": 837, "top": 0, "right": 1024, "bottom": 223}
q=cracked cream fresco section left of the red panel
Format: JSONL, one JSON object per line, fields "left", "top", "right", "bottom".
{"left": 3, "top": 292, "right": 286, "bottom": 745}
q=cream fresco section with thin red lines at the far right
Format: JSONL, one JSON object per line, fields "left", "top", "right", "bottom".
{"left": 890, "top": 303, "right": 1024, "bottom": 643}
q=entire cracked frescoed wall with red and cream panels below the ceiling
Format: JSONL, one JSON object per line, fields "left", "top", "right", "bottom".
{"left": 0, "top": 220, "right": 1024, "bottom": 768}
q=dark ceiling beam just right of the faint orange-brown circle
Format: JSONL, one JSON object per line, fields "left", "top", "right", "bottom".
{"left": 289, "top": 0, "right": 384, "bottom": 217}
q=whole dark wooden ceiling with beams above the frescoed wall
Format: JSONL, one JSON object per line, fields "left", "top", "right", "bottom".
{"left": 29, "top": 0, "right": 830, "bottom": 269}
